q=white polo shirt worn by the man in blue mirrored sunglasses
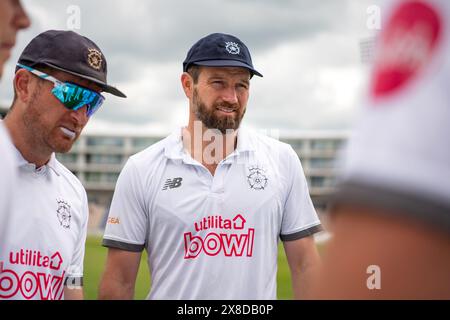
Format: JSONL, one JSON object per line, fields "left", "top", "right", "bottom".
{"left": 0, "top": 141, "right": 88, "bottom": 300}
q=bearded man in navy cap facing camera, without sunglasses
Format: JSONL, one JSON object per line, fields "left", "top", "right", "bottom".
{"left": 100, "top": 33, "right": 320, "bottom": 299}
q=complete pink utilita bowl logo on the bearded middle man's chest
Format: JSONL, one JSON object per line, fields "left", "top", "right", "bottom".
{"left": 184, "top": 214, "right": 255, "bottom": 259}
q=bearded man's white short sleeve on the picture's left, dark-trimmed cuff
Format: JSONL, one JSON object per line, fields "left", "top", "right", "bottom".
{"left": 103, "top": 158, "right": 148, "bottom": 252}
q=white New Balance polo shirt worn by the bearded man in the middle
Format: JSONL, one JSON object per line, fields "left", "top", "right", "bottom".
{"left": 103, "top": 129, "right": 320, "bottom": 299}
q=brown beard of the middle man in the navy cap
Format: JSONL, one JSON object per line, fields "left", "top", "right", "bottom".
{"left": 192, "top": 89, "right": 246, "bottom": 134}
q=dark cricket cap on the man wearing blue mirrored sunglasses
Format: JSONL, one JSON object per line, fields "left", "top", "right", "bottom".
{"left": 18, "top": 30, "right": 126, "bottom": 98}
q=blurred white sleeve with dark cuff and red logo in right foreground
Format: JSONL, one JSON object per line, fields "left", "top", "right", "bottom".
{"left": 336, "top": 0, "right": 450, "bottom": 231}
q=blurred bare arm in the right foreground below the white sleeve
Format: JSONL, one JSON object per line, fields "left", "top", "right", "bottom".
{"left": 312, "top": 205, "right": 450, "bottom": 299}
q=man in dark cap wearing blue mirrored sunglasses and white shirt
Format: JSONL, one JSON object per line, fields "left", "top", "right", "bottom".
{"left": 0, "top": 30, "right": 125, "bottom": 300}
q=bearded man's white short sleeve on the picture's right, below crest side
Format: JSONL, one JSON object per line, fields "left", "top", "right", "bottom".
{"left": 280, "top": 146, "right": 322, "bottom": 241}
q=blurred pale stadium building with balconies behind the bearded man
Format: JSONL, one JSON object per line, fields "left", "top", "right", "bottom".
{"left": 0, "top": 108, "right": 348, "bottom": 229}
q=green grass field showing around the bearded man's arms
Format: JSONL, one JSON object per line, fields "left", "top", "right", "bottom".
{"left": 84, "top": 236, "right": 292, "bottom": 300}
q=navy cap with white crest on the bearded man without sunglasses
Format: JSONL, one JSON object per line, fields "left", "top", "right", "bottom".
{"left": 183, "top": 33, "right": 263, "bottom": 77}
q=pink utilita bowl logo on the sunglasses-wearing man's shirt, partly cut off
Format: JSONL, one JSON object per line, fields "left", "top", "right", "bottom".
{"left": 0, "top": 249, "right": 65, "bottom": 300}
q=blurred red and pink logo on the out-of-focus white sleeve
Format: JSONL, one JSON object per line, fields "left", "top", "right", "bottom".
{"left": 371, "top": 1, "right": 442, "bottom": 98}
